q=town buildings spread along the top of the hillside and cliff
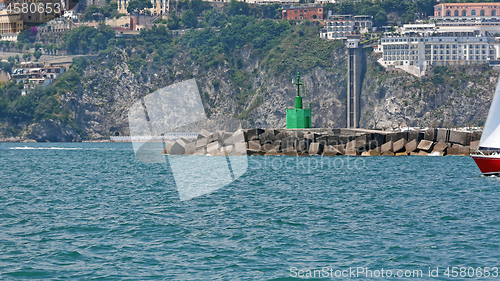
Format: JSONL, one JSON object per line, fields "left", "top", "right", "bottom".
{"left": 0, "top": 0, "right": 500, "bottom": 83}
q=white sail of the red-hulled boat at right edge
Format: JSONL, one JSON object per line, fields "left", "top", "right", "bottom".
{"left": 479, "top": 74, "right": 500, "bottom": 149}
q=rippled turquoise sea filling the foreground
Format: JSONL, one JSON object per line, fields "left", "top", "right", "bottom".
{"left": 0, "top": 143, "right": 500, "bottom": 280}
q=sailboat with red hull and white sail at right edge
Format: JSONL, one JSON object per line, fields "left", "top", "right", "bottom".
{"left": 471, "top": 75, "right": 500, "bottom": 175}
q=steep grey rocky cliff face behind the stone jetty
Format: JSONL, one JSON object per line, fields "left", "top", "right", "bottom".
{"left": 8, "top": 38, "right": 498, "bottom": 141}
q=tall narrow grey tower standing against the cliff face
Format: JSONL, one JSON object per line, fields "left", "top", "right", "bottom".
{"left": 347, "top": 37, "right": 363, "bottom": 128}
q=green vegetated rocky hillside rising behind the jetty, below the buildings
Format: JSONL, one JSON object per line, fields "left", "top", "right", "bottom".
{"left": 0, "top": 0, "right": 493, "bottom": 139}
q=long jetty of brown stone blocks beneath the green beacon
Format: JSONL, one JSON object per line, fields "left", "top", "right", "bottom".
{"left": 163, "top": 128, "right": 482, "bottom": 156}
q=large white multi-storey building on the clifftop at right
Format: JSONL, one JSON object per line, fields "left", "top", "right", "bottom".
{"left": 379, "top": 20, "right": 500, "bottom": 76}
